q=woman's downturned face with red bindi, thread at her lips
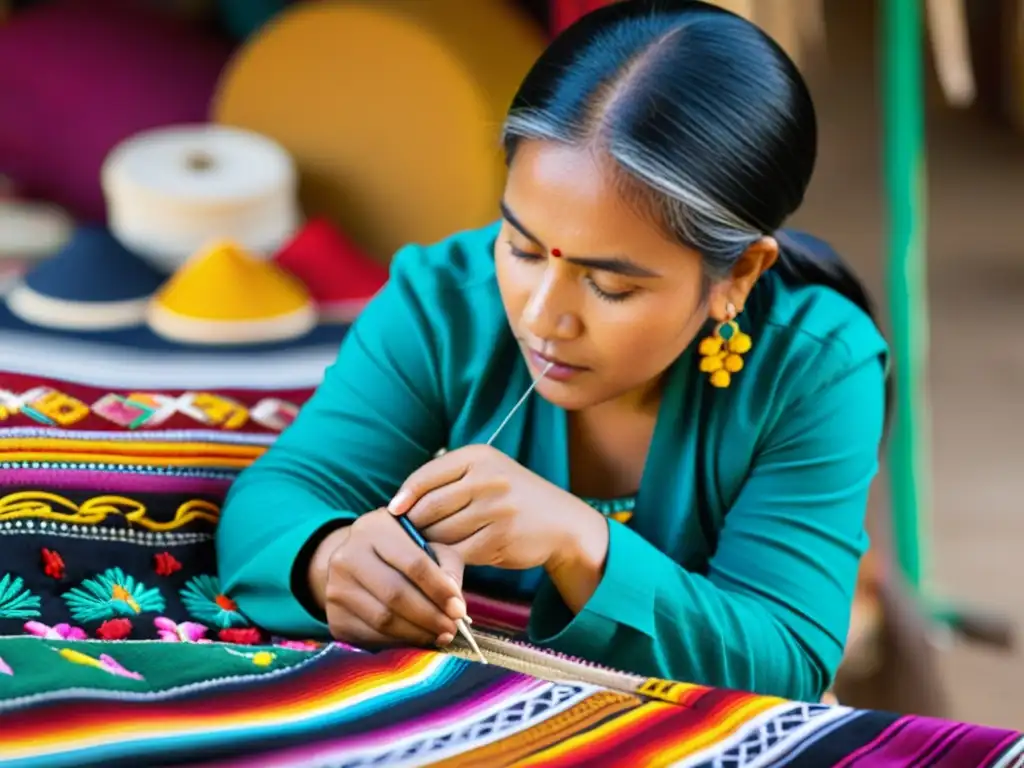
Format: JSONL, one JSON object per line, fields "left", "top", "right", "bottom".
{"left": 495, "top": 141, "right": 720, "bottom": 410}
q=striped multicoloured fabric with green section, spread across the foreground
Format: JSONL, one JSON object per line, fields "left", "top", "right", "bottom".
{"left": 0, "top": 638, "right": 1024, "bottom": 768}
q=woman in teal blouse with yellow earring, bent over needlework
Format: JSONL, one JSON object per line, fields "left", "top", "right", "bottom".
{"left": 218, "top": 0, "right": 887, "bottom": 699}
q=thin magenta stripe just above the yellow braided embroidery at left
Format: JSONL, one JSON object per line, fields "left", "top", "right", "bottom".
{"left": 0, "top": 469, "right": 231, "bottom": 496}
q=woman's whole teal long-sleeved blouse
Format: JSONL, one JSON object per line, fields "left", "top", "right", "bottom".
{"left": 217, "top": 225, "right": 887, "bottom": 700}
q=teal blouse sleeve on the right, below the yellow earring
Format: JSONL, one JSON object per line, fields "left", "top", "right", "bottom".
{"left": 530, "top": 348, "right": 885, "bottom": 700}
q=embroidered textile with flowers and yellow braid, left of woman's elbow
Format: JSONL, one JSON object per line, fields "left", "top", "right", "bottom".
{"left": 0, "top": 374, "right": 311, "bottom": 643}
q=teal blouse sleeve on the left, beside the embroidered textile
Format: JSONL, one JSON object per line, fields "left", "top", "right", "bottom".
{"left": 217, "top": 248, "right": 447, "bottom": 637}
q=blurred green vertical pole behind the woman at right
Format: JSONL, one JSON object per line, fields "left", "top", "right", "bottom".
{"left": 884, "top": 0, "right": 931, "bottom": 589}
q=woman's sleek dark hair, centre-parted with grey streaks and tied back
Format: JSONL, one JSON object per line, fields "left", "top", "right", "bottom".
{"left": 503, "top": 0, "right": 873, "bottom": 333}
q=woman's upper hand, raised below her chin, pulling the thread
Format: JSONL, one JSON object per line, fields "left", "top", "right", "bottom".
{"left": 388, "top": 445, "right": 608, "bottom": 571}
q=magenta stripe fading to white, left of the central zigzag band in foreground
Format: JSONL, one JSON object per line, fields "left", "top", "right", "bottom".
{"left": 201, "top": 675, "right": 552, "bottom": 768}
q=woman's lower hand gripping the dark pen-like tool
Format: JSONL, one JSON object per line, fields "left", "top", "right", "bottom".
{"left": 309, "top": 509, "right": 466, "bottom": 646}
